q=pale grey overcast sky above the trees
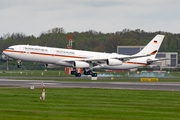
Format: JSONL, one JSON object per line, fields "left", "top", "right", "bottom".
{"left": 0, "top": 0, "right": 180, "bottom": 36}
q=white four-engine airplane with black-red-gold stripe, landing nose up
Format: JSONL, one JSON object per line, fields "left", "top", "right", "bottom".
{"left": 2, "top": 35, "right": 164, "bottom": 77}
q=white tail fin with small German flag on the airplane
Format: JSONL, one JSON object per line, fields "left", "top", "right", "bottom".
{"left": 136, "top": 35, "right": 164, "bottom": 58}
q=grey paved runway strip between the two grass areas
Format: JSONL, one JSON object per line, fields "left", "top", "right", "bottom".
{"left": 0, "top": 79, "right": 180, "bottom": 91}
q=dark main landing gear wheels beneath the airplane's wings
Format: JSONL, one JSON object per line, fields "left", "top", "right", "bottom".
{"left": 71, "top": 68, "right": 97, "bottom": 77}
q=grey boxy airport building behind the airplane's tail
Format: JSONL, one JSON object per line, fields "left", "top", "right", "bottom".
{"left": 117, "top": 46, "right": 178, "bottom": 68}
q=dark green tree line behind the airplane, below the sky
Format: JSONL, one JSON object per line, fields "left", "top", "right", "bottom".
{"left": 0, "top": 28, "right": 180, "bottom": 62}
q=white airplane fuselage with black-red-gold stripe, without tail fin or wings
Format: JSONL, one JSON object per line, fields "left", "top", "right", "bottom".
{"left": 3, "top": 45, "right": 147, "bottom": 70}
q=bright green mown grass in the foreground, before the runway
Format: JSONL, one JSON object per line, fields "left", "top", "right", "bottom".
{"left": 0, "top": 88, "right": 180, "bottom": 120}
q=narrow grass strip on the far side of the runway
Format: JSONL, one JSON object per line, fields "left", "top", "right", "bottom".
{"left": 0, "top": 70, "right": 180, "bottom": 82}
